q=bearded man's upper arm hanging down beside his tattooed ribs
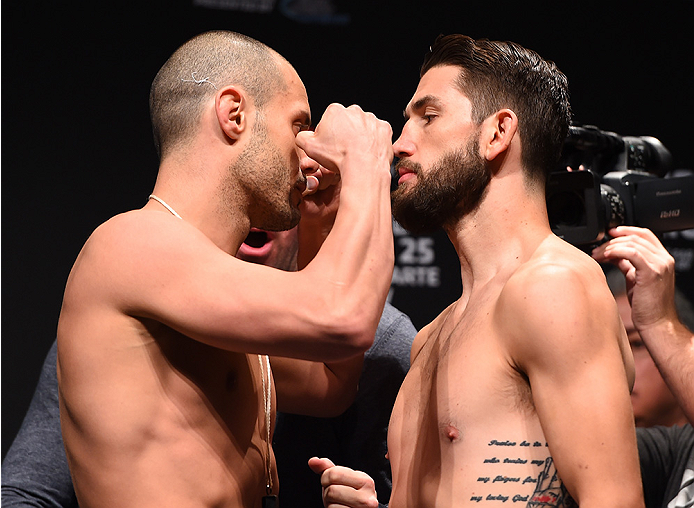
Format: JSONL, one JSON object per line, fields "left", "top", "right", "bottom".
{"left": 506, "top": 270, "right": 638, "bottom": 504}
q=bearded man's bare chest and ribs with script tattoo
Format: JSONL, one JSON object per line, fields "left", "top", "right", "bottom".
{"left": 388, "top": 312, "right": 553, "bottom": 506}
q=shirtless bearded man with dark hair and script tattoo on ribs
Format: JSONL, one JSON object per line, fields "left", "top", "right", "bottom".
{"left": 310, "top": 35, "right": 643, "bottom": 508}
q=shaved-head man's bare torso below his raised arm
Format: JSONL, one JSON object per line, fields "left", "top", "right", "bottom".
{"left": 63, "top": 318, "right": 278, "bottom": 506}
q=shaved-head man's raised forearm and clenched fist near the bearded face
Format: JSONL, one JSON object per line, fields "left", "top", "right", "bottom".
{"left": 290, "top": 104, "right": 394, "bottom": 350}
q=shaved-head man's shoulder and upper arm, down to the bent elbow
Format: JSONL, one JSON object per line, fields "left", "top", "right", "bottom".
{"left": 81, "top": 217, "right": 344, "bottom": 358}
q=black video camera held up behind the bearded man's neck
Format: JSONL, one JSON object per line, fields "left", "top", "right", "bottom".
{"left": 546, "top": 125, "right": 694, "bottom": 245}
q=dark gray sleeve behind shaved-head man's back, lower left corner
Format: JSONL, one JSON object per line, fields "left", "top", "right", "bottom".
{"left": 1, "top": 342, "right": 77, "bottom": 508}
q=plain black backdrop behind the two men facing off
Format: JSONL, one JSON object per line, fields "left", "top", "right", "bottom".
{"left": 2, "top": 0, "right": 694, "bottom": 457}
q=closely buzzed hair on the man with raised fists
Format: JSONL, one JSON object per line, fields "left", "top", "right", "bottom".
{"left": 149, "top": 30, "right": 286, "bottom": 157}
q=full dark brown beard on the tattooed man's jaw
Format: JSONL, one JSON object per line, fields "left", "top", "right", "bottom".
{"left": 390, "top": 139, "right": 491, "bottom": 235}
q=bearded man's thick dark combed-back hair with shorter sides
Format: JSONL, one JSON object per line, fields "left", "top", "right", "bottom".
{"left": 420, "top": 34, "right": 571, "bottom": 185}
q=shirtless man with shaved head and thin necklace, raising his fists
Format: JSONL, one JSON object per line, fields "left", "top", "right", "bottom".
{"left": 58, "top": 31, "right": 393, "bottom": 508}
